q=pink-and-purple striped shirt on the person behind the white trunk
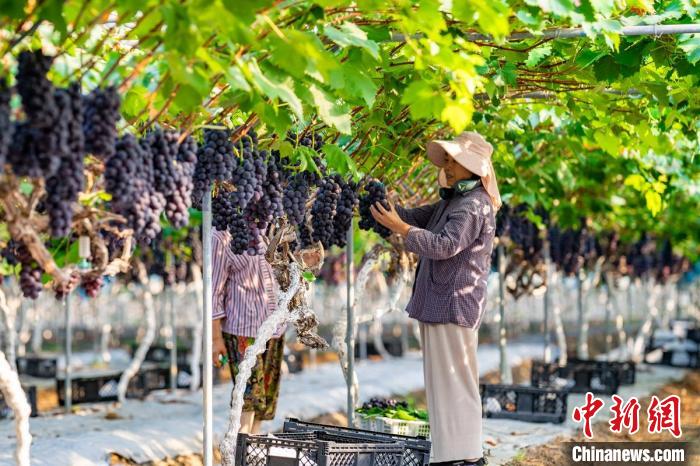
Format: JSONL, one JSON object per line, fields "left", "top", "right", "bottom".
{"left": 212, "top": 230, "right": 285, "bottom": 337}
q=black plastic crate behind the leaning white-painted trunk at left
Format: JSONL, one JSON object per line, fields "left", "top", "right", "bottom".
{"left": 56, "top": 372, "right": 149, "bottom": 406}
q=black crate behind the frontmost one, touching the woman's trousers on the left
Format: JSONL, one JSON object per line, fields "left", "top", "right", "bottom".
{"left": 283, "top": 419, "right": 431, "bottom": 466}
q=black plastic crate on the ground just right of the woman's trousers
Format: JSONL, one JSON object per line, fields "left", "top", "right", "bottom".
{"left": 479, "top": 384, "right": 568, "bottom": 424}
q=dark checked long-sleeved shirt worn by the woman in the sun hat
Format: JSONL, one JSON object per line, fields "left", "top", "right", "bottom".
{"left": 397, "top": 187, "right": 496, "bottom": 328}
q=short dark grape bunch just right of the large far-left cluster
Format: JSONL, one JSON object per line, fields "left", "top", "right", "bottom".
{"left": 84, "top": 86, "right": 121, "bottom": 160}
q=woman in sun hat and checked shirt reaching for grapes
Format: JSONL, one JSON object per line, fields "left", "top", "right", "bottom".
{"left": 371, "top": 132, "right": 501, "bottom": 466}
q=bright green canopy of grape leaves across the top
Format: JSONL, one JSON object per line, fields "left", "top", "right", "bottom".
{"left": 0, "top": 0, "right": 700, "bottom": 254}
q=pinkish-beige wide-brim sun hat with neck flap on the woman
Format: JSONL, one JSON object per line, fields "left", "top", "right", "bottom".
{"left": 427, "top": 131, "right": 501, "bottom": 209}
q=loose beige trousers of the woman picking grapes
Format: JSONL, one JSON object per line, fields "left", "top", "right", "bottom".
{"left": 420, "top": 323, "right": 483, "bottom": 462}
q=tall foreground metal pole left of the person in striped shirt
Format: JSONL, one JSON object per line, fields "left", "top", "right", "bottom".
{"left": 202, "top": 189, "right": 214, "bottom": 466}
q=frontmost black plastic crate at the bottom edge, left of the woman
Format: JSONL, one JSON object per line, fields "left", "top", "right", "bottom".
{"left": 236, "top": 431, "right": 404, "bottom": 466}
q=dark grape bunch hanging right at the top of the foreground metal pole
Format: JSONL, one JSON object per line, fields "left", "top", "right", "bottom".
{"left": 192, "top": 129, "right": 236, "bottom": 208}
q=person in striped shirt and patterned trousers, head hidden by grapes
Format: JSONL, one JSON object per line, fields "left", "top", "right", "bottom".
{"left": 212, "top": 231, "right": 285, "bottom": 433}
